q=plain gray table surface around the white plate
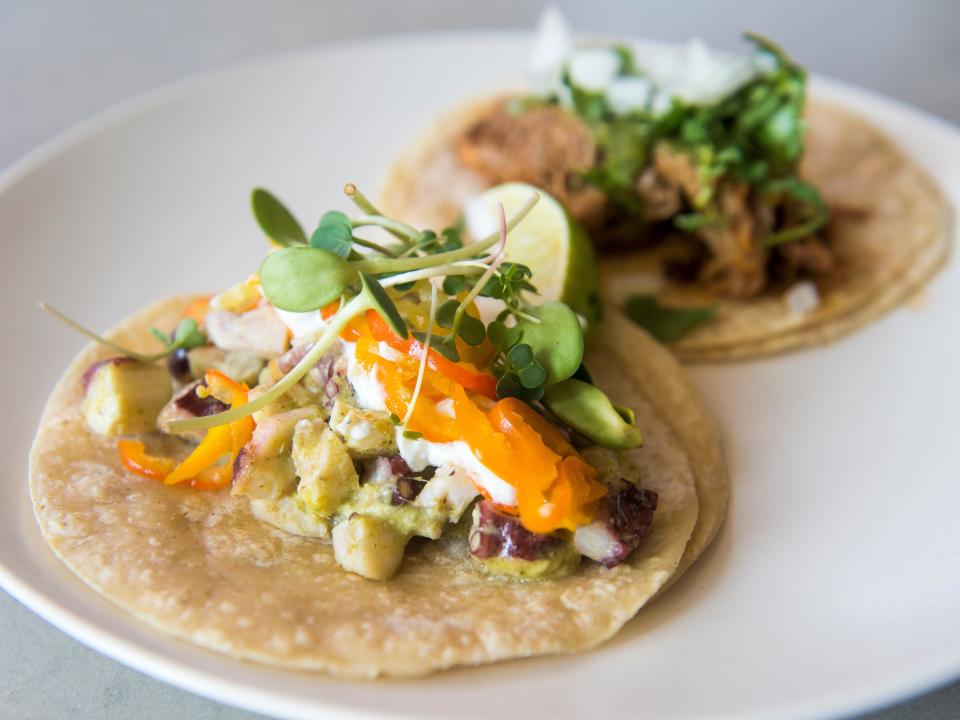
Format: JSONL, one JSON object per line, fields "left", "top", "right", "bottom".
{"left": 0, "top": 0, "right": 960, "bottom": 720}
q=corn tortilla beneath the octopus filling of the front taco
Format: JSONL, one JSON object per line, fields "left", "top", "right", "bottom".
{"left": 30, "top": 298, "right": 726, "bottom": 678}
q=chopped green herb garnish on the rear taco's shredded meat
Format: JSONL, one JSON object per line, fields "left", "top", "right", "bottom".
{"left": 544, "top": 33, "right": 828, "bottom": 246}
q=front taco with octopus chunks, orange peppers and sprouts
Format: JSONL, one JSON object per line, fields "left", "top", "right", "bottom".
{"left": 30, "top": 186, "right": 728, "bottom": 678}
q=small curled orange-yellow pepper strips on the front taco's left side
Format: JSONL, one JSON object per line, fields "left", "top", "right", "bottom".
{"left": 117, "top": 369, "right": 255, "bottom": 490}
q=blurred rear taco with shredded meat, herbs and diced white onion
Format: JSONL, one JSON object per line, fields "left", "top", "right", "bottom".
{"left": 381, "top": 16, "right": 951, "bottom": 361}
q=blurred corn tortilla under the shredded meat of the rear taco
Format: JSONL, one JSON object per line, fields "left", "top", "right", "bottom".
{"left": 381, "top": 96, "right": 952, "bottom": 362}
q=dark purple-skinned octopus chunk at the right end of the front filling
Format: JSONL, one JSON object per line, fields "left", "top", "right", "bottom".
{"left": 573, "top": 478, "right": 657, "bottom": 568}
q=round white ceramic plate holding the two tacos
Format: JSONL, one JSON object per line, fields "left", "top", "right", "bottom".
{"left": 0, "top": 34, "right": 960, "bottom": 719}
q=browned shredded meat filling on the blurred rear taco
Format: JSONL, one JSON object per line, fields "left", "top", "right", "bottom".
{"left": 456, "top": 101, "right": 837, "bottom": 299}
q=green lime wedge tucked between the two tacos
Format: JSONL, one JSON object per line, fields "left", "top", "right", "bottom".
{"left": 466, "top": 183, "right": 600, "bottom": 325}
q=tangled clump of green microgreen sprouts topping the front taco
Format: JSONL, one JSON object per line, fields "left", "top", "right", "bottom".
{"left": 171, "top": 184, "right": 583, "bottom": 437}
